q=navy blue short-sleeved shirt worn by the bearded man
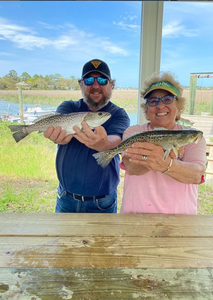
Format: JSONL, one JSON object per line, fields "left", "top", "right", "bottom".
{"left": 56, "top": 99, "right": 130, "bottom": 196}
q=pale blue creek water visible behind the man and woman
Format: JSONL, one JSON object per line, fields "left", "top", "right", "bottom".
{"left": 0, "top": 100, "right": 137, "bottom": 125}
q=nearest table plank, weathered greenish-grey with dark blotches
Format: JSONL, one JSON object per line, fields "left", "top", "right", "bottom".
{"left": 0, "top": 269, "right": 213, "bottom": 300}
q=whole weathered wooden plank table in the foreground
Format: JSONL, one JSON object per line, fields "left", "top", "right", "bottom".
{"left": 0, "top": 213, "right": 213, "bottom": 300}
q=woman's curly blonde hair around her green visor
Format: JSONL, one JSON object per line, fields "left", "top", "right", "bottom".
{"left": 140, "top": 72, "right": 186, "bottom": 121}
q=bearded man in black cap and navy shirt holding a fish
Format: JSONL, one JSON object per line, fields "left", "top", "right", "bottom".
{"left": 44, "top": 59, "right": 130, "bottom": 213}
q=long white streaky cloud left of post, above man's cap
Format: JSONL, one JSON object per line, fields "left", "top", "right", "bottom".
{"left": 0, "top": 18, "right": 128, "bottom": 56}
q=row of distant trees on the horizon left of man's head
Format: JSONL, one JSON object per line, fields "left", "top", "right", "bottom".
{"left": 0, "top": 70, "right": 79, "bottom": 90}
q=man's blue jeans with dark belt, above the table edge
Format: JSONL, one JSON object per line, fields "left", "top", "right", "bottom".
{"left": 55, "top": 187, "right": 117, "bottom": 213}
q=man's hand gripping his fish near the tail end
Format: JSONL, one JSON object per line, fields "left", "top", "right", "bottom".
{"left": 44, "top": 126, "right": 73, "bottom": 145}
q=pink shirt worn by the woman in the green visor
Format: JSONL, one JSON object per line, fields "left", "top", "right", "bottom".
{"left": 120, "top": 123, "right": 206, "bottom": 214}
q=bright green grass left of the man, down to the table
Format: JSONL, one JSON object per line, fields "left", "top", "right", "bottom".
{"left": 0, "top": 122, "right": 58, "bottom": 212}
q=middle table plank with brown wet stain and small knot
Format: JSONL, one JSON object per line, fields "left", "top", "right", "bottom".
{"left": 0, "top": 236, "right": 213, "bottom": 269}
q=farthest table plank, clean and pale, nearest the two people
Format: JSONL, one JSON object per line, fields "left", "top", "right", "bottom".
{"left": 0, "top": 213, "right": 213, "bottom": 237}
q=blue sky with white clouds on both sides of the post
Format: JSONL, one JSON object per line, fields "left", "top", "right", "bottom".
{"left": 0, "top": 1, "right": 213, "bottom": 88}
